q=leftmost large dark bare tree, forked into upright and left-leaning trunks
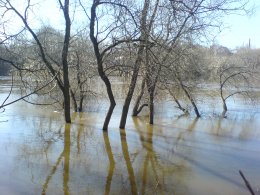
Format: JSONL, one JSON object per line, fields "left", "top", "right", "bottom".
{"left": 0, "top": 0, "right": 71, "bottom": 123}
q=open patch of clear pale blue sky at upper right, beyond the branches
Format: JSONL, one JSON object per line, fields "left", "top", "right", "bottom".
{"left": 216, "top": 0, "right": 260, "bottom": 49}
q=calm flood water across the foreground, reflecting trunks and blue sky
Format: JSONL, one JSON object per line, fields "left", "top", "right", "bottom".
{"left": 0, "top": 77, "right": 260, "bottom": 195}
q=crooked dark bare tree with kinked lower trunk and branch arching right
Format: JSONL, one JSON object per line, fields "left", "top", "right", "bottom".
{"left": 90, "top": 0, "right": 138, "bottom": 130}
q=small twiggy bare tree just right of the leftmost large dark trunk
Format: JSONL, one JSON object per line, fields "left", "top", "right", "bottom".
{"left": 69, "top": 32, "right": 97, "bottom": 112}
